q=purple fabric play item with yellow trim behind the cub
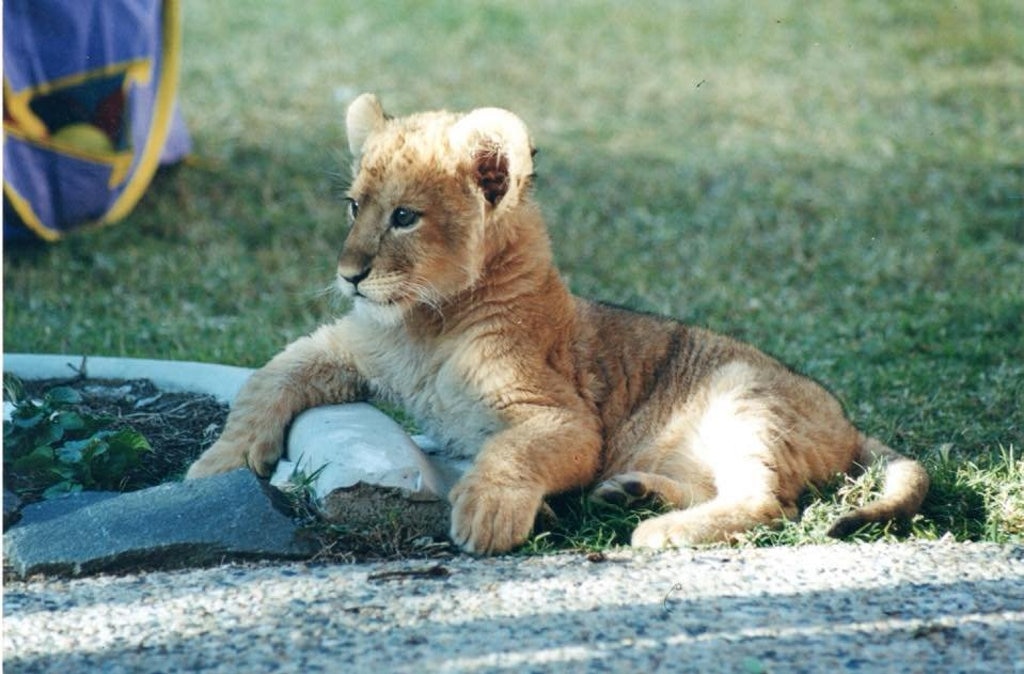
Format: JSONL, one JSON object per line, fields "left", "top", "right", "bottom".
{"left": 3, "top": 0, "right": 190, "bottom": 241}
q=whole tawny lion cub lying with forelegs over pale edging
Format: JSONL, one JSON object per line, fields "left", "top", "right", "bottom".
{"left": 188, "top": 94, "right": 929, "bottom": 553}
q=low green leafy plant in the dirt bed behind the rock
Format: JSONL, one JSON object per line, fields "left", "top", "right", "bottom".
{"left": 3, "top": 376, "right": 152, "bottom": 499}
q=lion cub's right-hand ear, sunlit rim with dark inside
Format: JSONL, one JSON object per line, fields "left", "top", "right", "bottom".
{"left": 450, "top": 108, "right": 534, "bottom": 211}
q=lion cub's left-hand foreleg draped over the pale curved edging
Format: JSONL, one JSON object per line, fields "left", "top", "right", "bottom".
{"left": 186, "top": 325, "right": 367, "bottom": 478}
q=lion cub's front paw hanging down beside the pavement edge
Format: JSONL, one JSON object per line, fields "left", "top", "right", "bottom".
{"left": 449, "top": 474, "right": 544, "bottom": 554}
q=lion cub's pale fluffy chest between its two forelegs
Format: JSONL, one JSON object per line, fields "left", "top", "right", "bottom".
{"left": 357, "top": 323, "right": 503, "bottom": 458}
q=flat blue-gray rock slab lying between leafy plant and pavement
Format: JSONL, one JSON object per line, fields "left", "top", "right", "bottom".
{"left": 3, "top": 469, "right": 315, "bottom": 577}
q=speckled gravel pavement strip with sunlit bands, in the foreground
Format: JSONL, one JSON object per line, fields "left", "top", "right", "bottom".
{"left": 3, "top": 542, "right": 1024, "bottom": 674}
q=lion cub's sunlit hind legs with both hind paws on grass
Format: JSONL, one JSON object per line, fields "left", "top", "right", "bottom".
{"left": 597, "top": 363, "right": 804, "bottom": 548}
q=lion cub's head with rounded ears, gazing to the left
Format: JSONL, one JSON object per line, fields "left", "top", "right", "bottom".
{"left": 338, "top": 94, "right": 532, "bottom": 322}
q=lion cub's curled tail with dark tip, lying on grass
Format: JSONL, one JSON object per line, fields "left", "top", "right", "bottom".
{"left": 828, "top": 435, "right": 931, "bottom": 538}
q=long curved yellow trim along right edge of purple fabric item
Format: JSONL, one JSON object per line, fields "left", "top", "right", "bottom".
{"left": 100, "top": 0, "right": 181, "bottom": 223}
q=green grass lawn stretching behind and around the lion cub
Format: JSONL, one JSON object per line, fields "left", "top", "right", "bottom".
{"left": 3, "top": 0, "right": 1024, "bottom": 542}
